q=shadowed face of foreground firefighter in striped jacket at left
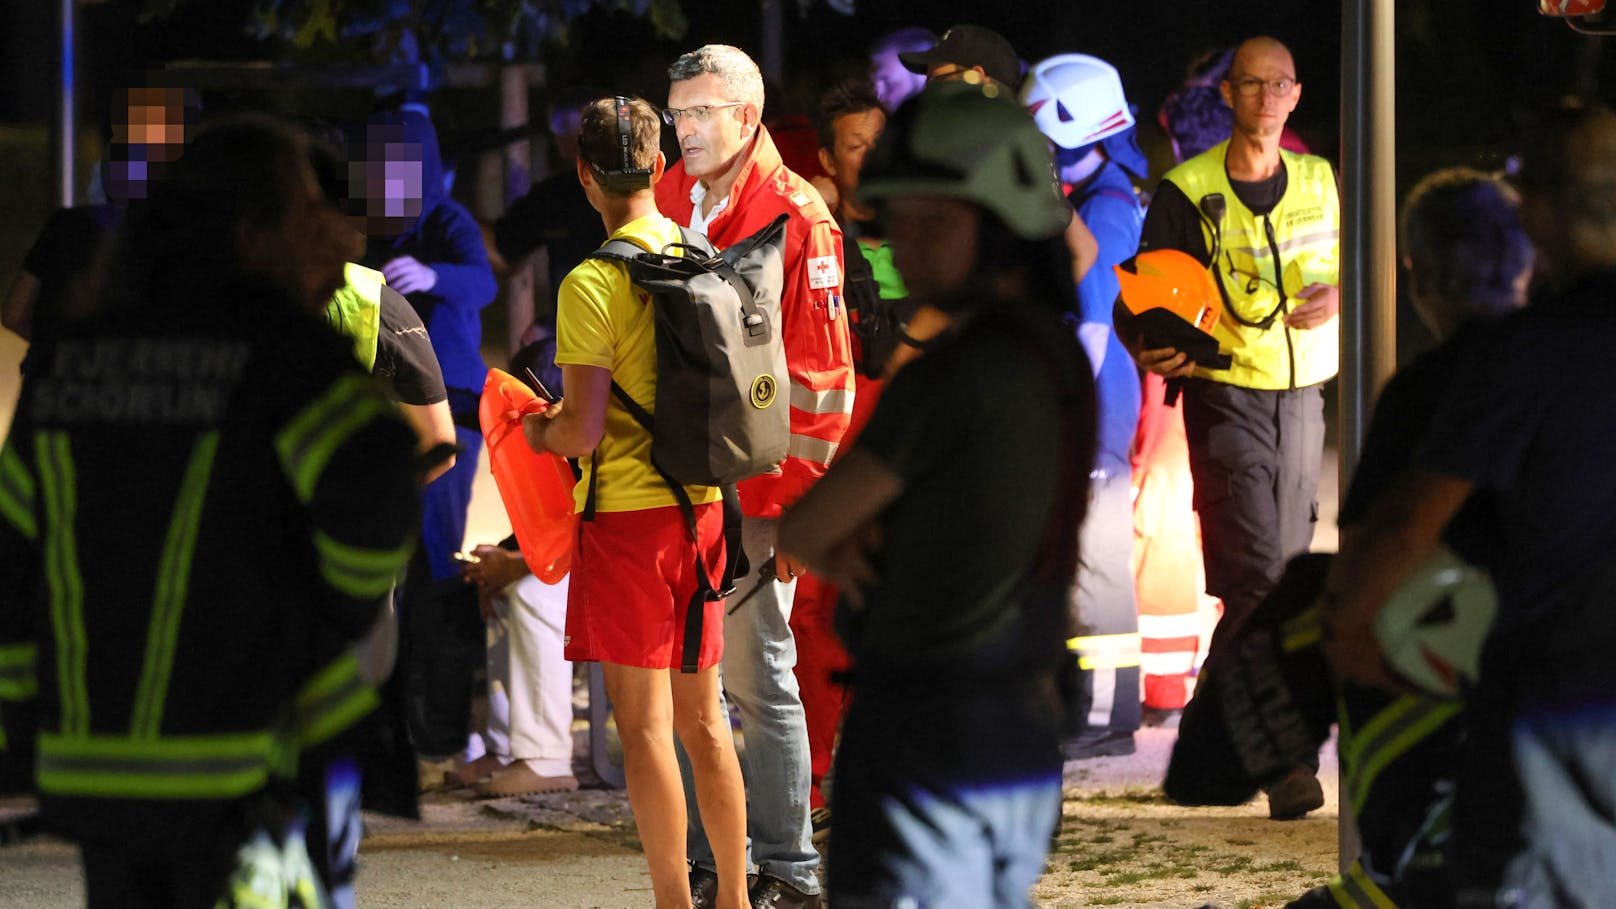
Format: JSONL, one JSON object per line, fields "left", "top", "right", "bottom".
{"left": 239, "top": 154, "right": 364, "bottom": 311}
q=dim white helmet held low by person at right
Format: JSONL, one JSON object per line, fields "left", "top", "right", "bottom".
{"left": 1375, "top": 547, "right": 1498, "bottom": 697}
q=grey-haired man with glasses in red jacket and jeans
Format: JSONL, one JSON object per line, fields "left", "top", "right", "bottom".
{"left": 656, "top": 44, "right": 853, "bottom": 907}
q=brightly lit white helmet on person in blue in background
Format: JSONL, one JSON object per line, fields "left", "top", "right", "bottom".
{"left": 1021, "top": 53, "right": 1133, "bottom": 149}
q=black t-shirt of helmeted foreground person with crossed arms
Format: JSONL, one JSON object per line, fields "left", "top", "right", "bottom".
{"left": 837, "top": 304, "right": 1094, "bottom": 686}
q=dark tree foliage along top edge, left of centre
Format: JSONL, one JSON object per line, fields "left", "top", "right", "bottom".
{"left": 142, "top": 0, "right": 688, "bottom": 65}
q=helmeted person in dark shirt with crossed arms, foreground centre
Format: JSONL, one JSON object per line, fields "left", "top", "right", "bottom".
{"left": 779, "top": 82, "right": 1094, "bottom": 909}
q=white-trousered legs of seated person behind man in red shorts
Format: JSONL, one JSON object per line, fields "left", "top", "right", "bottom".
{"left": 448, "top": 545, "right": 579, "bottom": 797}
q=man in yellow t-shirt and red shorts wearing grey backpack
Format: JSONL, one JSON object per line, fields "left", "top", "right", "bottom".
{"left": 524, "top": 97, "right": 747, "bottom": 909}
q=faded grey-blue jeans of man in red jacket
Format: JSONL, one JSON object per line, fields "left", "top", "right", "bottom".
{"left": 679, "top": 518, "right": 819, "bottom": 893}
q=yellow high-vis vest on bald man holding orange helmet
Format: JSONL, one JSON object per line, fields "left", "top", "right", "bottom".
{"left": 1165, "top": 142, "right": 1341, "bottom": 390}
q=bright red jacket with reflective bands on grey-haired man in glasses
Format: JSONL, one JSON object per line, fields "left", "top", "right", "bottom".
{"left": 656, "top": 128, "right": 853, "bottom": 518}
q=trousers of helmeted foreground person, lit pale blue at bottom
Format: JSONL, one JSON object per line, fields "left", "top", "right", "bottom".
{"left": 829, "top": 678, "right": 1062, "bottom": 909}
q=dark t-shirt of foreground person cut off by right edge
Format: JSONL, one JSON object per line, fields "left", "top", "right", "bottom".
{"left": 1417, "top": 270, "right": 1616, "bottom": 637}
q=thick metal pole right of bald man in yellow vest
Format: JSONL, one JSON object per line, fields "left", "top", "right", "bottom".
{"left": 1338, "top": 0, "right": 1398, "bottom": 872}
